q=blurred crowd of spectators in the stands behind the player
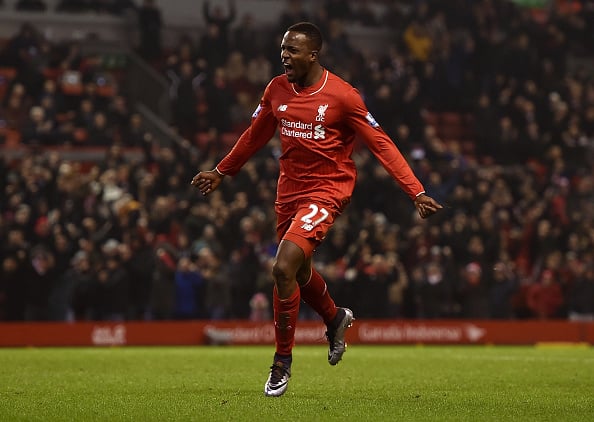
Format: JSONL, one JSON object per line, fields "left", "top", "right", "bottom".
{"left": 0, "top": 0, "right": 594, "bottom": 321}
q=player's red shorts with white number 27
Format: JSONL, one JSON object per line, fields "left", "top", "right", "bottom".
{"left": 275, "top": 200, "right": 340, "bottom": 258}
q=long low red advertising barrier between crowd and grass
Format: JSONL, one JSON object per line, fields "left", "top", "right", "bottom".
{"left": 0, "top": 320, "right": 594, "bottom": 347}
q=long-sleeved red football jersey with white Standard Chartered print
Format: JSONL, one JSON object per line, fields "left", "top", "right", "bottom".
{"left": 217, "top": 70, "right": 424, "bottom": 209}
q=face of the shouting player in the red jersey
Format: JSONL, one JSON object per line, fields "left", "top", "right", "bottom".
{"left": 281, "top": 31, "right": 318, "bottom": 85}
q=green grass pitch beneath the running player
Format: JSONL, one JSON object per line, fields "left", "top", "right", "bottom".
{"left": 0, "top": 345, "right": 594, "bottom": 422}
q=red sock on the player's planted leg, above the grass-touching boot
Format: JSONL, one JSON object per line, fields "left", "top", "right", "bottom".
{"left": 272, "top": 286, "right": 301, "bottom": 356}
